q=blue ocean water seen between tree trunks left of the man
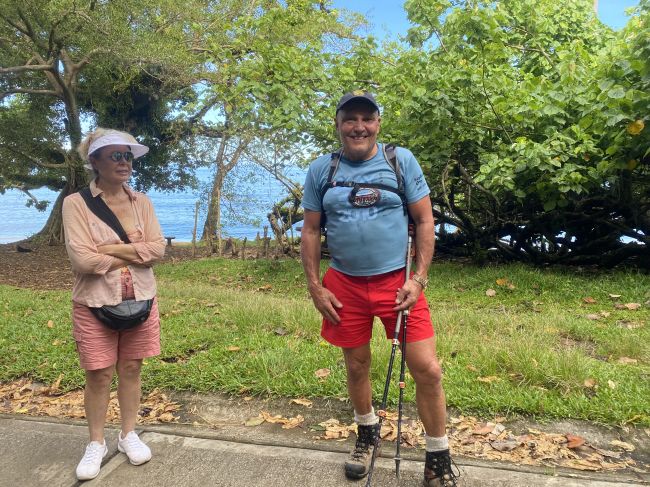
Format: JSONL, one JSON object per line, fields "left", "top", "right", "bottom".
{"left": 0, "top": 169, "right": 304, "bottom": 243}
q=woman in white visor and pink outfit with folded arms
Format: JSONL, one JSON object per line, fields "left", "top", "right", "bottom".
{"left": 63, "top": 128, "right": 165, "bottom": 480}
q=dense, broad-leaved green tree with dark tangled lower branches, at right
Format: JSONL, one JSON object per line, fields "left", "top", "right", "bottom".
{"left": 378, "top": 0, "right": 650, "bottom": 265}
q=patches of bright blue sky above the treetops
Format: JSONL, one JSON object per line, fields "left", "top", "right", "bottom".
{"left": 333, "top": 0, "right": 639, "bottom": 38}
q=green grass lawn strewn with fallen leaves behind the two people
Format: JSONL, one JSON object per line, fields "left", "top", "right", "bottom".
{"left": 0, "top": 259, "right": 650, "bottom": 426}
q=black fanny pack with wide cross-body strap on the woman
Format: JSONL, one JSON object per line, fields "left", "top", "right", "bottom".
{"left": 79, "top": 188, "right": 153, "bottom": 331}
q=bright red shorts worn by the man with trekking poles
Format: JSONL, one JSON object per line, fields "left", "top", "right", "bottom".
{"left": 321, "top": 268, "right": 434, "bottom": 348}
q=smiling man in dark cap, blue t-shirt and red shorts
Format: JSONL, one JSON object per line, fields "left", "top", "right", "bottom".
{"left": 301, "top": 90, "right": 457, "bottom": 487}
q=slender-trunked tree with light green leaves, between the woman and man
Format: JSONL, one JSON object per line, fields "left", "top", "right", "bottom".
{"left": 178, "top": 0, "right": 360, "bottom": 251}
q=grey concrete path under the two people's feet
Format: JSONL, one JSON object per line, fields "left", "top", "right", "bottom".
{"left": 0, "top": 416, "right": 650, "bottom": 487}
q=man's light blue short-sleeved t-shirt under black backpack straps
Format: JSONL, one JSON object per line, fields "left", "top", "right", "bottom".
{"left": 302, "top": 144, "right": 429, "bottom": 276}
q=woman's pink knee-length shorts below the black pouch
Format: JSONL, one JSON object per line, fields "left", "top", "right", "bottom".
{"left": 72, "top": 271, "right": 160, "bottom": 370}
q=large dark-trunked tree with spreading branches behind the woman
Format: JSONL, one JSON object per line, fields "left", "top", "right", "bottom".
{"left": 0, "top": 0, "right": 197, "bottom": 243}
